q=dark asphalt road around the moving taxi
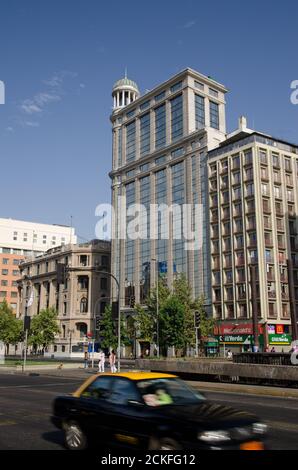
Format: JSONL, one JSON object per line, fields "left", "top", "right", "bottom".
{"left": 0, "top": 374, "right": 298, "bottom": 450}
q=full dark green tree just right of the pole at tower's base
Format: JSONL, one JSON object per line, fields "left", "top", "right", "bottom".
{"left": 160, "top": 294, "right": 186, "bottom": 349}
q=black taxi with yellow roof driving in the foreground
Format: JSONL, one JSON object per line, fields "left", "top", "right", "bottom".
{"left": 52, "top": 372, "right": 266, "bottom": 450}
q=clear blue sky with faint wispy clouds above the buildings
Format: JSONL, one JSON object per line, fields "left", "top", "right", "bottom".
{"left": 0, "top": 0, "right": 298, "bottom": 239}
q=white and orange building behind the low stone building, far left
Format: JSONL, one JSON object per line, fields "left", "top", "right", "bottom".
{"left": 0, "top": 218, "right": 76, "bottom": 312}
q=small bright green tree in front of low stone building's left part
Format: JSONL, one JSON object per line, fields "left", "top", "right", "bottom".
{"left": 28, "top": 307, "right": 60, "bottom": 351}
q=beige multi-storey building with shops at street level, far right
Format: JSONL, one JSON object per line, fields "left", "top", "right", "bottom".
{"left": 208, "top": 118, "right": 298, "bottom": 350}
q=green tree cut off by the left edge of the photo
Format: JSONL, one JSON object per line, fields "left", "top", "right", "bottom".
{"left": 0, "top": 300, "right": 23, "bottom": 353}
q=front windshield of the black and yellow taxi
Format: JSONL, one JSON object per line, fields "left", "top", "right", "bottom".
{"left": 137, "top": 378, "right": 205, "bottom": 407}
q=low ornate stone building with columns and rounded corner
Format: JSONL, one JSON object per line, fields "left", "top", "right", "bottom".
{"left": 18, "top": 240, "right": 110, "bottom": 356}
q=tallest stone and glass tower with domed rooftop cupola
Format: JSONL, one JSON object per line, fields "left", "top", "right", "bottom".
{"left": 110, "top": 68, "right": 227, "bottom": 315}
